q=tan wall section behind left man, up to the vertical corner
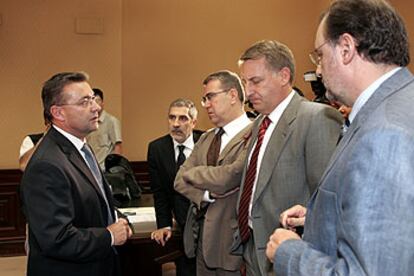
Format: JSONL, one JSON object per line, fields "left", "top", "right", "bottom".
{"left": 0, "top": 0, "right": 122, "bottom": 169}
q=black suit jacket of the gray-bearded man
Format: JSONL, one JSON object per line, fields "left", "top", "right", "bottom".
{"left": 147, "top": 131, "right": 202, "bottom": 228}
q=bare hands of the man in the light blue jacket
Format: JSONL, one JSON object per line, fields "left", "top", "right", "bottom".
{"left": 266, "top": 205, "right": 306, "bottom": 263}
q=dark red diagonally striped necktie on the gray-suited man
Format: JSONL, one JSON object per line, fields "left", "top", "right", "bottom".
{"left": 239, "top": 116, "right": 271, "bottom": 243}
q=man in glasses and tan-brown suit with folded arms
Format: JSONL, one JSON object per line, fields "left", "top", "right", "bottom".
{"left": 174, "top": 71, "right": 251, "bottom": 276}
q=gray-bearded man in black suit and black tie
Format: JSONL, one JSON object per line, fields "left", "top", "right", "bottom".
{"left": 147, "top": 99, "right": 201, "bottom": 276}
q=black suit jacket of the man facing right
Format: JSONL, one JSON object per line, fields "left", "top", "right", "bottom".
{"left": 21, "top": 127, "right": 119, "bottom": 276}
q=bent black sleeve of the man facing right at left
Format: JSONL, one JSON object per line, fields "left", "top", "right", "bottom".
{"left": 22, "top": 160, "right": 112, "bottom": 262}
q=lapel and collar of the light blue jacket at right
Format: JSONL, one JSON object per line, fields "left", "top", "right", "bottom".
{"left": 320, "top": 68, "right": 414, "bottom": 183}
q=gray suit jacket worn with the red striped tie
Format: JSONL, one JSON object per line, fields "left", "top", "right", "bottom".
{"left": 233, "top": 94, "right": 342, "bottom": 275}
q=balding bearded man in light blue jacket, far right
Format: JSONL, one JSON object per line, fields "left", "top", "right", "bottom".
{"left": 267, "top": 0, "right": 414, "bottom": 275}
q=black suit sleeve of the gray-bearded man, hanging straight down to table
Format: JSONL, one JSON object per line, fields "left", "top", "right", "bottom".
{"left": 147, "top": 143, "right": 173, "bottom": 228}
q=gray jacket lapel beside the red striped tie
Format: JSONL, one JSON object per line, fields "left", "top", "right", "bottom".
{"left": 253, "top": 95, "right": 303, "bottom": 202}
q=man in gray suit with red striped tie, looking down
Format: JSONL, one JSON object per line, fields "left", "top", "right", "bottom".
{"left": 233, "top": 41, "right": 342, "bottom": 276}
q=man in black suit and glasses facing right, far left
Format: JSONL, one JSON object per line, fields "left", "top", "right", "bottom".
{"left": 21, "top": 73, "right": 131, "bottom": 276}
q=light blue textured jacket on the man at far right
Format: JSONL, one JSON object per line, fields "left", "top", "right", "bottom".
{"left": 275, "top": 68, "right": 414, "bottom": 275}
